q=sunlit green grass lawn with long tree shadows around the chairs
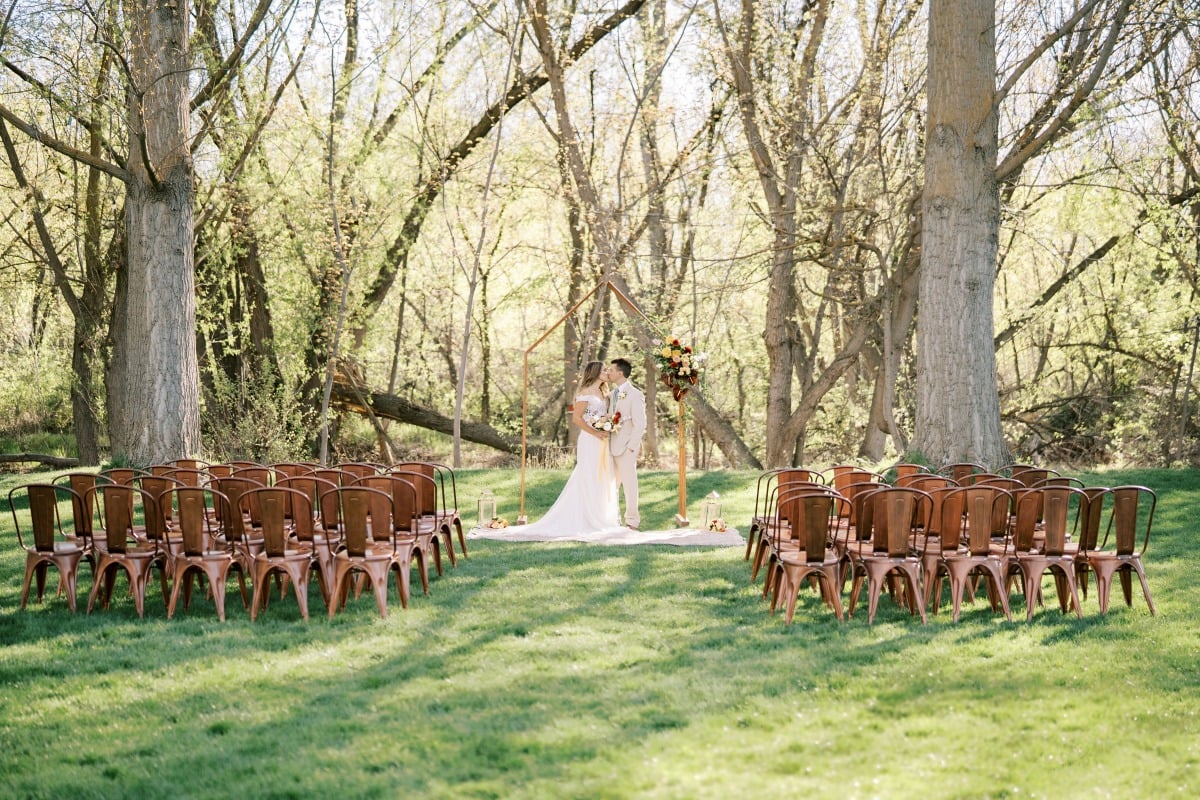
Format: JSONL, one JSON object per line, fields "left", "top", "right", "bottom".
{"left": 0, "top": 470, "right": 1200, "bottom": 798}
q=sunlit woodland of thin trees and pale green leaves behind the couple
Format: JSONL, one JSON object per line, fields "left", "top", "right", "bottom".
{"left": 0, "top": 0, "right": 1200, "bottom": 468}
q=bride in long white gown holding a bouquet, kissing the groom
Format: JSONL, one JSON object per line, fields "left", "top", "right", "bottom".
{"left": 487, "top": 361, "right": 628, "bottom": 541}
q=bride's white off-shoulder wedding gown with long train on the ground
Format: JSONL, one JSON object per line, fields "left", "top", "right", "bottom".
{"left": 480, "top": 395, "right": 629, "bottom": 542}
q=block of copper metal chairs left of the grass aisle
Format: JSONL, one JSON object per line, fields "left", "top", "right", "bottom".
{"left": 8, "top": 462, "right": 467, "bottom": 620}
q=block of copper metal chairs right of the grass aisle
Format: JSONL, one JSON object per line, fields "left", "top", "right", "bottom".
{"left": 746, "top": 468, "right": 1157, "bottom": 624}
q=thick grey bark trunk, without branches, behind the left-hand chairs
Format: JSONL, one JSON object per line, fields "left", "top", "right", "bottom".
{"left": 109, "top": 0, "right": 200, "bottom": 464}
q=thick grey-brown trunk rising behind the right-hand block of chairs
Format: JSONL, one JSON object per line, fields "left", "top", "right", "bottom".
{"left": 913, "top": 0, "right": 1008, "bottom": 467}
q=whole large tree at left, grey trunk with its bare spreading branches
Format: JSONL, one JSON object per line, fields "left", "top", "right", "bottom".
{"left": 0, "top": 0, "right": 276, "bottom": 463}
